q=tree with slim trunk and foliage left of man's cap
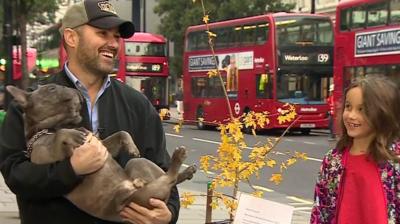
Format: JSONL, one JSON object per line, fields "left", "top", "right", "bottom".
{"left": 15, "top": 0, "right": 58, "bottom": 89}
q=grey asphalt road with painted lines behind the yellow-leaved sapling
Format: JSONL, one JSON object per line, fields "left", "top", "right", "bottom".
{"left": 164, "top": 116, "right": 334, "bottom": 223}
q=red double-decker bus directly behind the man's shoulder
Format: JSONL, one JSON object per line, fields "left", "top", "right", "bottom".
{"left": 116, "top": 32, "right": 169, "bottom": 110}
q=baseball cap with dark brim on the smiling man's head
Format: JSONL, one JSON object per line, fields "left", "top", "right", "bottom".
{"left": 60, "top": 0, "right": 135, "bottom": 38}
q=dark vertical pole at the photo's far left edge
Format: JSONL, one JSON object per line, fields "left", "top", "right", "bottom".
{"left": 3, "top": 0, "right": 13, "bottom": 110}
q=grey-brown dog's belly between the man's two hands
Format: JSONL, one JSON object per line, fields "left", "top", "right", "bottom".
{"left": 66, "top": 156, "right": 136, "bottom": 222}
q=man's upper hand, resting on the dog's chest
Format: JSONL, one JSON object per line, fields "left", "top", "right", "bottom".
{"left": 70, "top": 134, "right": 108, "bottom": 175}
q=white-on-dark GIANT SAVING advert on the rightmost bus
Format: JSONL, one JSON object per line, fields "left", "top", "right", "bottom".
{"left": 354, "top": 28, "right": 400, "bottom": 57}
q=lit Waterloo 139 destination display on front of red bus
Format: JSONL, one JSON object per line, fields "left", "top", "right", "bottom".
{"left": 280, "top": 52, "right": 332, "bottom": 65}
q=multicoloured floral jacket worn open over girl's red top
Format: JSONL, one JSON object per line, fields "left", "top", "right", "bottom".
{"left": 310, "top": 142, "right": 400, "bottom": 224}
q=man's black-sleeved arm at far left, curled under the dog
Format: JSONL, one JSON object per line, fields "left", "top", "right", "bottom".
{"left": 0, "top": 103, "right": 81, "bottom": 198}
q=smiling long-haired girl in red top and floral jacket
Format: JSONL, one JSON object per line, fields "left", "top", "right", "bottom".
{"left": 310, "top": 76, "right": 400, "bottom": 224}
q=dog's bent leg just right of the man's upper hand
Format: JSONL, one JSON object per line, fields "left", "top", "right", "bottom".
{"left": 102, "top": 131, "right": 140, "bottom": 157}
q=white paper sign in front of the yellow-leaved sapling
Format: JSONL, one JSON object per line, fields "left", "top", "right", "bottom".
{"left": 233, "top": 193, "right": 294, "bottom": 224}
